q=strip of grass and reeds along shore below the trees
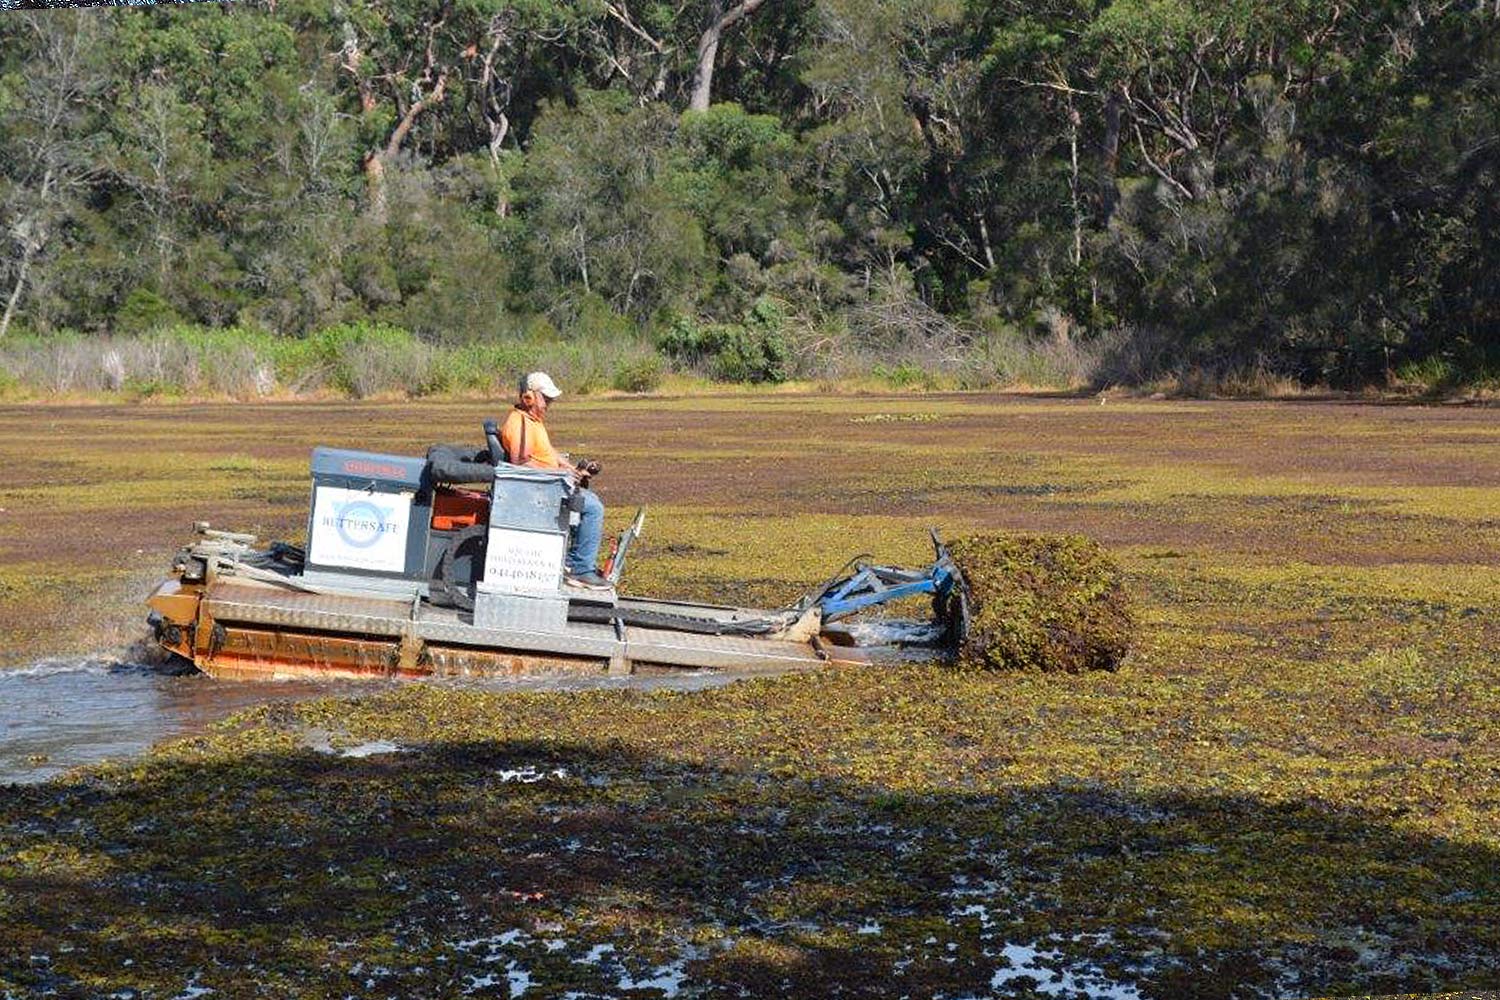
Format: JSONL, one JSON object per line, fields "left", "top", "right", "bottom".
{"left": 0, "top": 322, "right": 1500, "bottom": 403}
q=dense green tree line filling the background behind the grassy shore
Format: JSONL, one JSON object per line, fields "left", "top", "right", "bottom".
{"left": 0, "top": 0, "right": 1500, "bottom": 384}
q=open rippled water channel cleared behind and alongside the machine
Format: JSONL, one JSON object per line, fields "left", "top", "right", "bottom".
{"left": 0, "top": 658, "right": 798, "bottom": 784}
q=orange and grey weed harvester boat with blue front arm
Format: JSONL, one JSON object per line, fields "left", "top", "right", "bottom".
{"left": 147, "top": 421, "right": 968, "bottom": 678}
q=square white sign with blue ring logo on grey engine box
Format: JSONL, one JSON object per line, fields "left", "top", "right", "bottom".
{"left": 308, "top": 486, "right": 413, "bottom": 573}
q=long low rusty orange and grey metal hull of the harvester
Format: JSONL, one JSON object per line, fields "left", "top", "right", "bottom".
{"left": 147, "top": 577, "right": 869, "bottom": 679}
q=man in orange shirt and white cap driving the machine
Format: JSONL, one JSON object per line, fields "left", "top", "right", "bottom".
{"left": 500, "top": 372, "right": 611, "bottom": 591}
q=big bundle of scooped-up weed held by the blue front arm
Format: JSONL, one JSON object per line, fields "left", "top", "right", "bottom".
{"left": 948, "top": 535, "right": 1134, "bottom": 673}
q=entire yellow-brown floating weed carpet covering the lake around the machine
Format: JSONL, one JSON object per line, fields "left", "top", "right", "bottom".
{"left": 0, "top": 396, "right": 1500, "bottom": 997}
